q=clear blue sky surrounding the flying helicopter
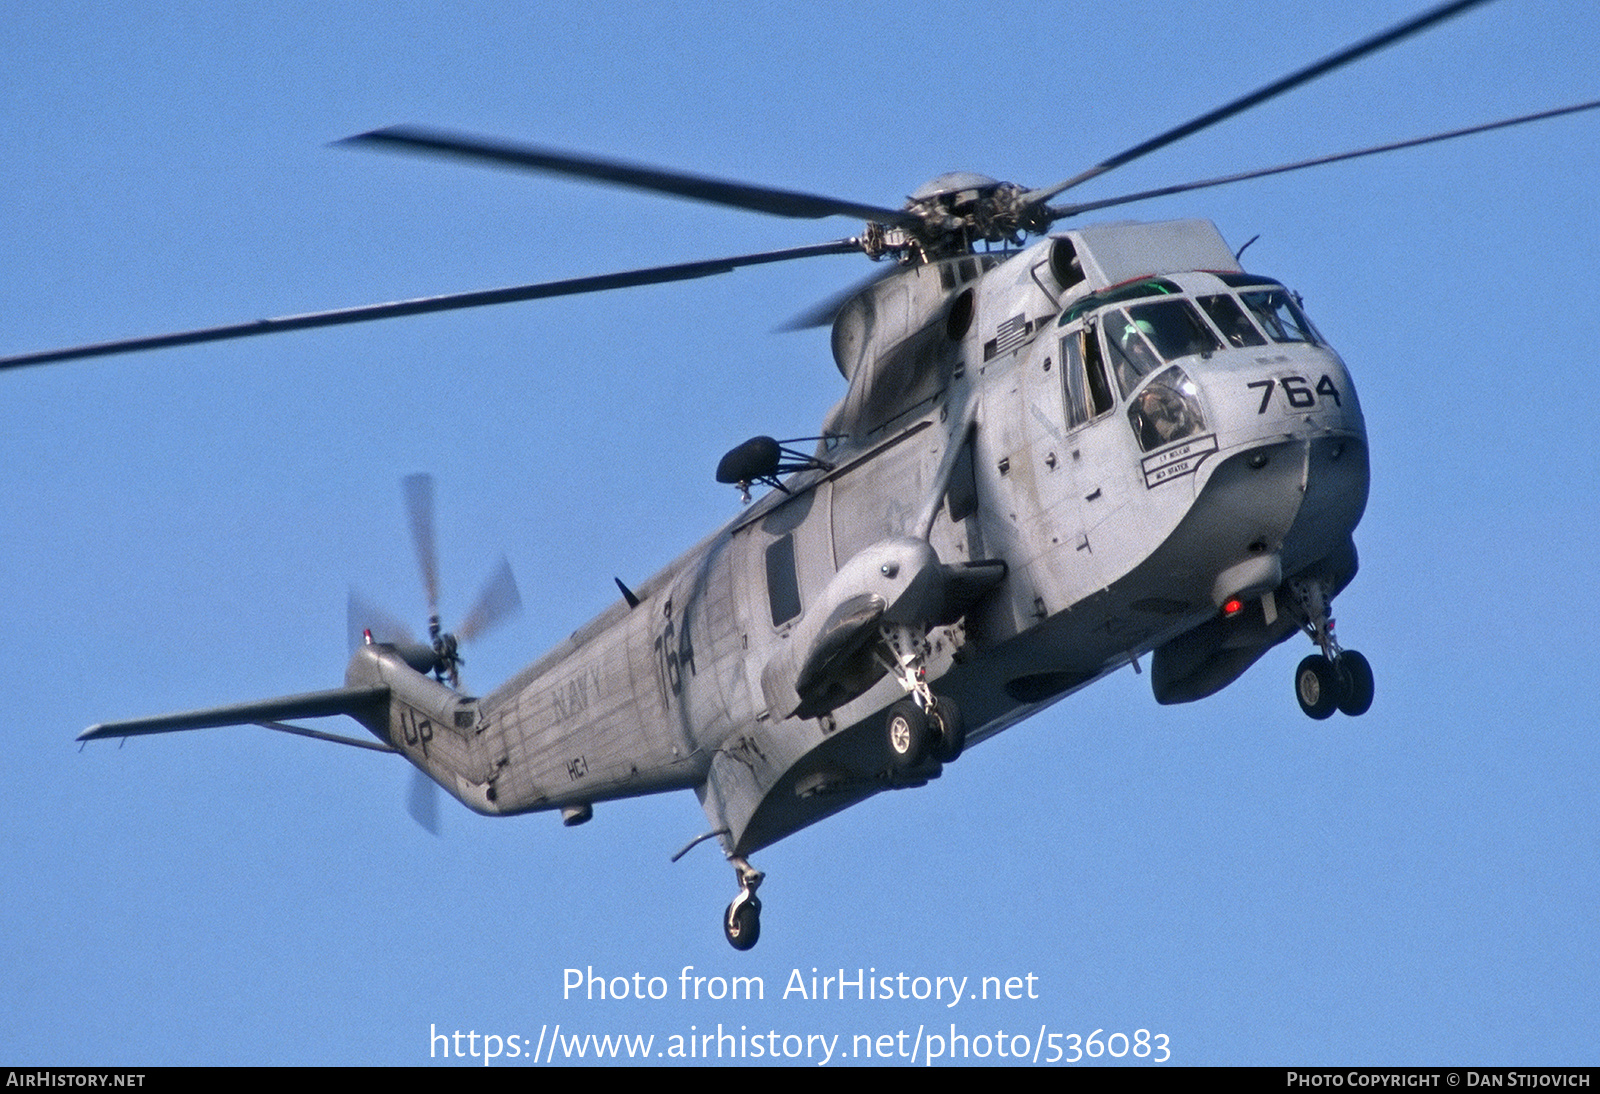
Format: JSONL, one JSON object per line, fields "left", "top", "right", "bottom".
{"left": 0, "top": 0, "right": 1600, "bottom": 1065}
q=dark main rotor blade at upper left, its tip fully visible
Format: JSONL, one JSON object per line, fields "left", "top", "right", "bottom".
{"left": 338, "top": 125, "right": 917, "bottom": 227}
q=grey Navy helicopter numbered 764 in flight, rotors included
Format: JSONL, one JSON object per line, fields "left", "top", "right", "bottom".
{"left": 15, "top": 0, "right": 1600, "bottom": 950}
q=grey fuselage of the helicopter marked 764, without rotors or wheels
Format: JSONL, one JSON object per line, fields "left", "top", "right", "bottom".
{"left": 350, "top": 221, "right": 1368, "bottom": 856}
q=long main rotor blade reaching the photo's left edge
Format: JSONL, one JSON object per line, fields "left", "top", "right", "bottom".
{"left": 0, "top": 237, "right": 861, "bottom": 369}
